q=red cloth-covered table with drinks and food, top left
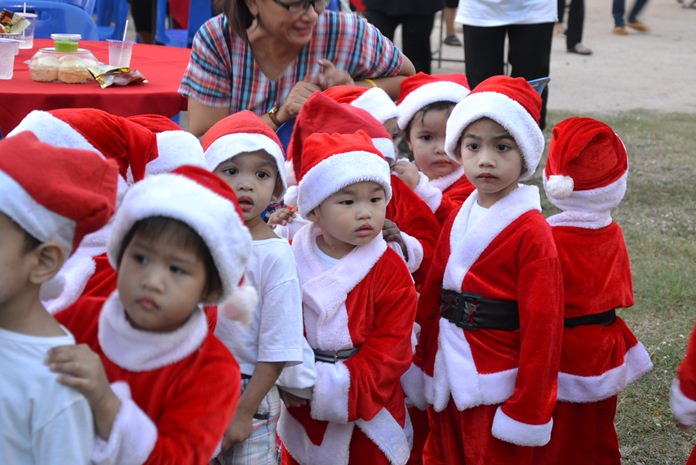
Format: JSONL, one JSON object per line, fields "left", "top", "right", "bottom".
{"left": 0, "top": 39, "right": 191, "bottom": 135}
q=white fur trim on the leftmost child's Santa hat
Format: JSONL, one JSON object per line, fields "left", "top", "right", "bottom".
{"left": 0, "top": 169, "right": 76, "bottom": 252}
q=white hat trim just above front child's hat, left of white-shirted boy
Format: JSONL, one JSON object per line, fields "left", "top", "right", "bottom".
{"left": 145, "top": 131, "right": 205, "bottom": 175}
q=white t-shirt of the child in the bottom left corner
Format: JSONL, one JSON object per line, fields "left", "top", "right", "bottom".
{"left": 0, "top": 328, "right": 94, "bottom": 465}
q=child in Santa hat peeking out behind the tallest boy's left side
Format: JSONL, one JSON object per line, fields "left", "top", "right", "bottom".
{"left": 394, "top": 73, "right": 474, "bottom": 224}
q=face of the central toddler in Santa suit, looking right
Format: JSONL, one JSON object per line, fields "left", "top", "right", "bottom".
{"left": 308, "top": 181, "right": 387, "bottom": 258}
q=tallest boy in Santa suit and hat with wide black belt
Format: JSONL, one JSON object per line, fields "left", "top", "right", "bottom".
{"left": 404, "top": 76, "right": 563, "bottom": 465}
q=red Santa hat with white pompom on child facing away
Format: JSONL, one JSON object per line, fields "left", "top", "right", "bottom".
{"left": 543, "top": 117, "right": 628, "bottom": 210}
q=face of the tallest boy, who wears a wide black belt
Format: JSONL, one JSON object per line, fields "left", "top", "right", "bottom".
{"left": 457, "top": 118, "right": 522, "bottom": 207}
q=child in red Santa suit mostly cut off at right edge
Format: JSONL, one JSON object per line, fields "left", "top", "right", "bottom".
{"left": 669, "top": 325, "right": 696, "bottom": 465}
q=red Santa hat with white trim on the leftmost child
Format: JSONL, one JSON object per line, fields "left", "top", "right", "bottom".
{"left": 0, "top": 132, "right": 118, "bottom": 254}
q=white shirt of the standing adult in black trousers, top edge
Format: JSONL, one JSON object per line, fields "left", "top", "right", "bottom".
{"left": 455, "top": 0, "right": 558, "bottom": 27}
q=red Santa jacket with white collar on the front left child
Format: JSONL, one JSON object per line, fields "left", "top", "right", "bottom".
{"left": 56, "top": 293, "right": 241, "bottom": 465}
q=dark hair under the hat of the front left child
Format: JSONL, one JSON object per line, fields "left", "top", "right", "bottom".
{"left": 118, "top": 216, "right": 222, "bottom": 294}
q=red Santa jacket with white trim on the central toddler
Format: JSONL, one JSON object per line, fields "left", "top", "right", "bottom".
{"left": 278, "top": 225, "right": 416, "bottom": 465}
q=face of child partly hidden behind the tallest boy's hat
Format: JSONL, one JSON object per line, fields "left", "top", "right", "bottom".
{"left": 408, "top": 109, "right": 458, "bottom": 179}
